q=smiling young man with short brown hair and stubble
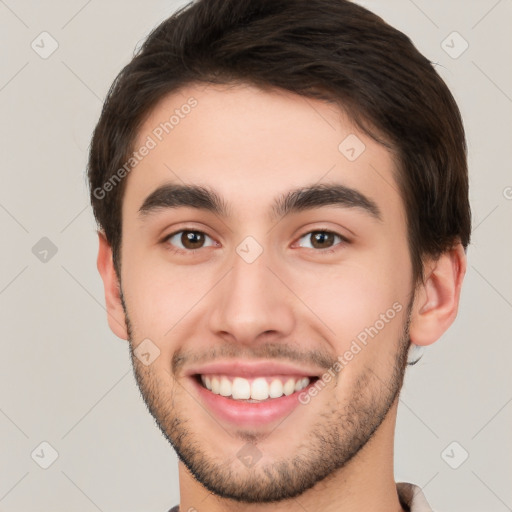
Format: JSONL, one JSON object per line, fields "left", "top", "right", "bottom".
{"left": 88, "top": 0, "right": 470, "bottom": 512}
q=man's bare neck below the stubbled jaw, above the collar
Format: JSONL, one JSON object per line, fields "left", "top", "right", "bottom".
{"left": 179, "top": 401, "right": 403, "bottom": 512}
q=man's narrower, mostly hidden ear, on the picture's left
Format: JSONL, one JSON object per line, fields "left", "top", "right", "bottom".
{"left": 97, "top": 231, "right": 128, "bottom": 340}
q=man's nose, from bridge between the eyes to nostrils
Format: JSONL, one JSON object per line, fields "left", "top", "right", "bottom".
{"left": 209, "top": 242, "right": 295, "bottom": 345}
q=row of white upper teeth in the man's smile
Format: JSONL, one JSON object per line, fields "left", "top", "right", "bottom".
{"left": 201, "top": 375, "right": 309, "bottom": 400}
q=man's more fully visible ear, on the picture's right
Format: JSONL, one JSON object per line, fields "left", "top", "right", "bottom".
{"left": 409, "top": 243, "right": 466, "bottom": 346}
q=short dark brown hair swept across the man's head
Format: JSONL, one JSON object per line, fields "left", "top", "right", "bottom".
{"left": 88, "top": 0, "right": 471, "bottom": 279}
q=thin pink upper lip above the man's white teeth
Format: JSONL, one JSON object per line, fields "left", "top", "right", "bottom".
{"left": 186, "top": 360, "right": 323, "bottom": 377}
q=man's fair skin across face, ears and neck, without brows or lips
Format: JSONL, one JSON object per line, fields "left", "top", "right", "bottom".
{"left": 98, "top": 85, "right": 466, "bottom": 512}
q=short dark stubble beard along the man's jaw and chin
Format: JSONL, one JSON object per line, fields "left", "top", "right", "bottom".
{"left": 123, "top": 294, "right": 412, "bottom": 503}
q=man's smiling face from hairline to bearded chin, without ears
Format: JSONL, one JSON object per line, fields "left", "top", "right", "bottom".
{"left": 115, "top": 82, "right": 413, "bottom": 502}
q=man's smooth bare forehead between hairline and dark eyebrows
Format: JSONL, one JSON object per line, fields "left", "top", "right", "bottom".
{"left": 123, "top": 84, "right": 402, "bottom": 222}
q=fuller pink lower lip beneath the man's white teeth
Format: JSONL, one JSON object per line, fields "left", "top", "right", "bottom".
{"left": 191, "top": 377, "right": 313, "bottom": 427}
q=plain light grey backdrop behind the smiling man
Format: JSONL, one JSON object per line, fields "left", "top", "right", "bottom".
{"left": 0, "top": 0, "right": 512, "bottom": 512}
